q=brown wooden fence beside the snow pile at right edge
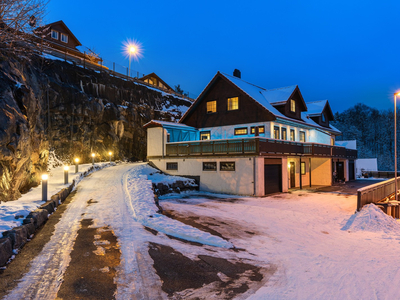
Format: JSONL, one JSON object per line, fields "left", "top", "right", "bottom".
{"left": 357, "top": 177, "right": 400, "bottom": 211}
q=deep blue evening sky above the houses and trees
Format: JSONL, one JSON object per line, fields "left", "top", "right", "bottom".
{"left": 45, "top": 0, "right": 400, "bottom": 112}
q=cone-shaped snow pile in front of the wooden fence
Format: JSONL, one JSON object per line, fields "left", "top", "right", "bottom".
{"left": 342, "top": 204, "right": 400, "bottom": 234}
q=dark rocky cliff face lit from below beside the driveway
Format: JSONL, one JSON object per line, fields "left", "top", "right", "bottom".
{"left": 0, "top": 54, "right": 191, "bottom": 201}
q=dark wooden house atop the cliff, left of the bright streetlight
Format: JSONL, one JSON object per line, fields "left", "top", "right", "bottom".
{"left": 34, "top": 20, "right": 101, "bottom": 65}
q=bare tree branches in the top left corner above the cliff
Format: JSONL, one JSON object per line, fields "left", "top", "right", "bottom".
{"left": 0, "top": 0, "right": 48, "bottom": 51}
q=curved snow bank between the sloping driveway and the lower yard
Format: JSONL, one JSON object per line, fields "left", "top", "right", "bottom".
{"left": 124, "top": 164, "right": 233, "bottom": 248}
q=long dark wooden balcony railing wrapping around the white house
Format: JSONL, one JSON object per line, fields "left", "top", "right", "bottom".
{"left": 166, "top": 138, "right": 357, "bottom": 159}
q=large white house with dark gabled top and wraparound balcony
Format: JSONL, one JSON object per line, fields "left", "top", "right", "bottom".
{"left": 144, "top": 70, "right": 357, "bottom": 196}
